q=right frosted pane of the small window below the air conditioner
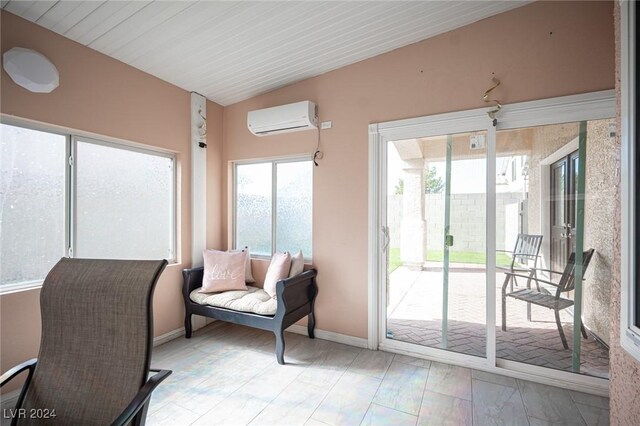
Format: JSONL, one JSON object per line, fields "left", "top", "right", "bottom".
{"left": 276, "top": 161, "right": 313, "bottom": 257}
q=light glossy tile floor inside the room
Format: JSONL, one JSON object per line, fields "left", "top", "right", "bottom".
{"left": 147, "top": 322, "right": 609, "bottom": 426}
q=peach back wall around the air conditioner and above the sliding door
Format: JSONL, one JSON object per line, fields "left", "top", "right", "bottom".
{"left": 222, "top": 2, "right": 614, "bottom": 337}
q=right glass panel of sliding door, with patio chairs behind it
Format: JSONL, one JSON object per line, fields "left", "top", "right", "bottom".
{"left": 495, "top": 119, "right": 616, "bottom": 378}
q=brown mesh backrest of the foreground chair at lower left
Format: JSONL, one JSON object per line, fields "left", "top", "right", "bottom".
{"left": 19, "top": 258, "right": 167, "bottom": 425}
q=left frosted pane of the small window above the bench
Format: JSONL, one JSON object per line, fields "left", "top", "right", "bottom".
{"left": 235, "top": 163, "right": 273, "bottom": 256}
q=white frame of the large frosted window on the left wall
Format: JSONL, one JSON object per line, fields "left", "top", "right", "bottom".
{"left": 0, "top": 118, "right": 178, "bottom": 295}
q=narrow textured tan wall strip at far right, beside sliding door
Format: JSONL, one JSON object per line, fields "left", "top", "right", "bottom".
{"left": 609, "top": 2, "right": 640, "bottom": 425}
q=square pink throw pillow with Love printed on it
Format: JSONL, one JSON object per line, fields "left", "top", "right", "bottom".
{"left": 200, "top": 250, "right": 247, "bottom": 293}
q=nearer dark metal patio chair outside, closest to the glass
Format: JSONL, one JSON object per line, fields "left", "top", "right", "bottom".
{"left": 502, "top": 249, "right": 595, "bottom": 349}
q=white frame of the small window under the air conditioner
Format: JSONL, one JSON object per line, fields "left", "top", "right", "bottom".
{"left": 231, "top": 154, "right": 313, "bottom": 262}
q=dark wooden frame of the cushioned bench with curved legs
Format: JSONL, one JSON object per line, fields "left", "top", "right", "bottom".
{"left": 182, "top": 267, "right": 318, "bottom": 364}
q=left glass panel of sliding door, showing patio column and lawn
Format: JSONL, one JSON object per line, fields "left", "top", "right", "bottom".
{"left": 386, "top": 131, "right": 486, "bottom": 357}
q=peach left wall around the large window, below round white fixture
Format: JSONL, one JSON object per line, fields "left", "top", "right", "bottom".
{"left": 0, "top": 12, "right": 222, "bottom": 391}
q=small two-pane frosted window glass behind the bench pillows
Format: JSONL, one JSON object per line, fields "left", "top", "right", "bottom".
{"left": 233, "top": 158, "right": 313, "bottom": 259}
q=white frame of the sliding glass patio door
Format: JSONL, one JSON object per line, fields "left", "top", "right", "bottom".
{"left": 368, "top": 90, "right": 616, "bottom": 395}
